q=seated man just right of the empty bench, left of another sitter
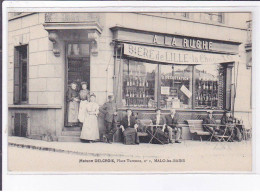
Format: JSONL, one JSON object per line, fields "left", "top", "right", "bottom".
{"left": 202, "top": 111, "right": 220, "bottom": 141}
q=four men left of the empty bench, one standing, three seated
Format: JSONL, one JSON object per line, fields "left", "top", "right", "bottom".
{"left": 100, "top": 99, "right": 181, "bottom": 144}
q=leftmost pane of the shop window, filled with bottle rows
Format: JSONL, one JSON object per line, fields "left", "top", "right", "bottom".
{"left": 122, "top": 60, "right": 158, "bottom": 108}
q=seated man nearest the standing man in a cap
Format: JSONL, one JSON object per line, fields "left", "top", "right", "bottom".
{"left": 120, "top": 109, "right": 139, "bottom": 144}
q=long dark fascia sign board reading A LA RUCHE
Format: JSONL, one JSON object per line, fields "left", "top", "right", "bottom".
{"left": 111, "top": 27, "right": 240, "bottom": 54}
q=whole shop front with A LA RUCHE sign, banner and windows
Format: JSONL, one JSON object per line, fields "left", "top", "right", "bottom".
{"left": 107, "top": 27, "right": 240, "bottom": 138}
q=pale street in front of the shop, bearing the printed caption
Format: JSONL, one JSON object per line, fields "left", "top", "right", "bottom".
{"left": 8, "top": 139, "right": 252, "bottom": 173}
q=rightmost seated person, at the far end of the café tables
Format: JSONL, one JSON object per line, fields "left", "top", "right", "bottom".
{"left": 221, "top": 111, "right": 242, "bottom": 141}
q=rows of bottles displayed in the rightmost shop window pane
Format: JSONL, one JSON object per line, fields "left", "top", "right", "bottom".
{"left": 195, "top": 80, "right": 219, "bottom": 109}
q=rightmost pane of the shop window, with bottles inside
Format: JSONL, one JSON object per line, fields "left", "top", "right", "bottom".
{"left": 194, "top": 64, "right": 232, "bottom": 110}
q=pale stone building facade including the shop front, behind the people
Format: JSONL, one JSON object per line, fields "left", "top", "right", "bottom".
{"left": 8, "top": 13, "right": 252, "bottom": 141}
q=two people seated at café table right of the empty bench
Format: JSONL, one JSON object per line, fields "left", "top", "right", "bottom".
{"left": 202, "top": 111, "right": 242, "bottom": 141}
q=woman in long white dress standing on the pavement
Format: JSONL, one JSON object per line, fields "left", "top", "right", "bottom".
{"left": 80, "top": 94, "right": 99, "bottom": 143}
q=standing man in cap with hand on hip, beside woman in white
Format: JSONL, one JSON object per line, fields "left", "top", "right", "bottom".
{"left": 100, "top": 95, "right": 117, "bottom": 142}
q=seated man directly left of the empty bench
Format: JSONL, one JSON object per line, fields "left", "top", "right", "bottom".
{"left": 165, "top": 109, "right": 181, "bottom": 143}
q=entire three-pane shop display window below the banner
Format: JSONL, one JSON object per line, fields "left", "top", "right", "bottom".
{"left": 120, "top": 59, "right": 232, "bottom": 110}
